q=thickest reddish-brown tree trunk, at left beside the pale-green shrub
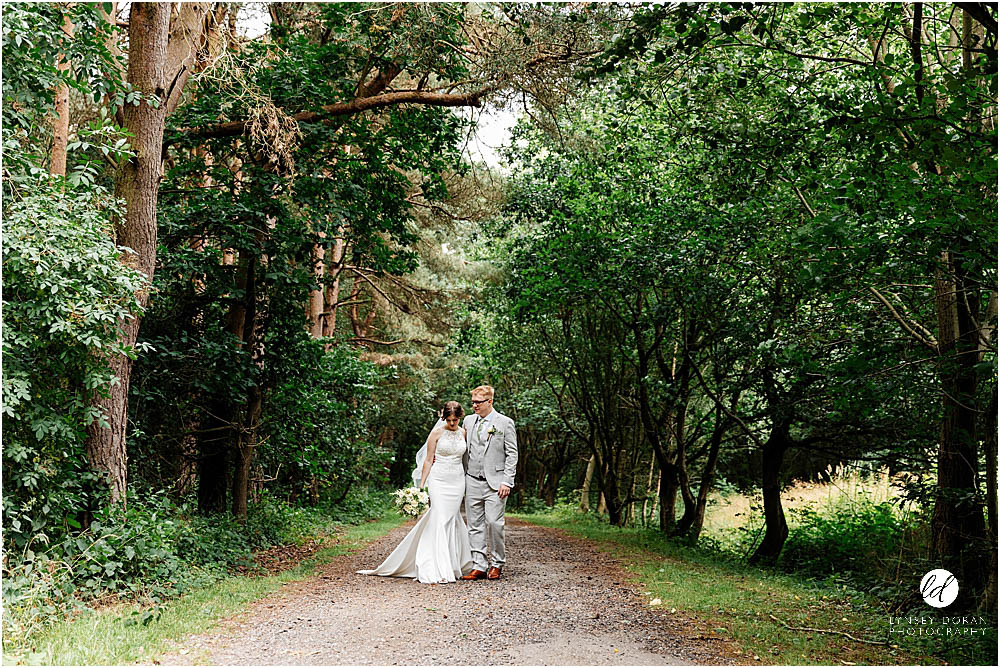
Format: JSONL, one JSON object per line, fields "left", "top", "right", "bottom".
{"left": 87, "top": 2, "right": 173, "bottom": 504}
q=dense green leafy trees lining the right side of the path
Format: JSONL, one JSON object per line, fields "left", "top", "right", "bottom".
{"left": 474, "top": 5, "right": 996, "bottom": 612}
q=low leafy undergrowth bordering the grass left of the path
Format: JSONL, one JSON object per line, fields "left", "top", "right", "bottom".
{"left": 3, "top": 492, "right": 389, "bottom": 650}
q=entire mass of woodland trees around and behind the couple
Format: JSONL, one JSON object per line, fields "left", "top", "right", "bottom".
{"left": 3, "top": 3, "right": 997, "bottom": 620}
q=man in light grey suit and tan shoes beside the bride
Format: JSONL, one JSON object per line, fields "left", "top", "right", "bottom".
{"left": 462, "top": 385, "right": 517, "bottom": 580}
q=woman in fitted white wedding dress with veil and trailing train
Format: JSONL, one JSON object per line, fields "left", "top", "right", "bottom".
{"left": 358, "top": 401, "right": 472, "bottom": 584}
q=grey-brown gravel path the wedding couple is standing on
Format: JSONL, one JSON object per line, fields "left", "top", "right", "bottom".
{"left": 159, "top": 519, "right": 733, "bottom": 665}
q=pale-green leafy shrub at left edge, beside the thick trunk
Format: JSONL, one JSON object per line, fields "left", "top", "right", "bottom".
{"left": 2, "top": 179, "right": 142, "bottom": 552}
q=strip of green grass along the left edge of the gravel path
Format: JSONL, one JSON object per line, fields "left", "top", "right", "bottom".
{"left": 3, "top": 514, "right": 405, "bottom": 665}
